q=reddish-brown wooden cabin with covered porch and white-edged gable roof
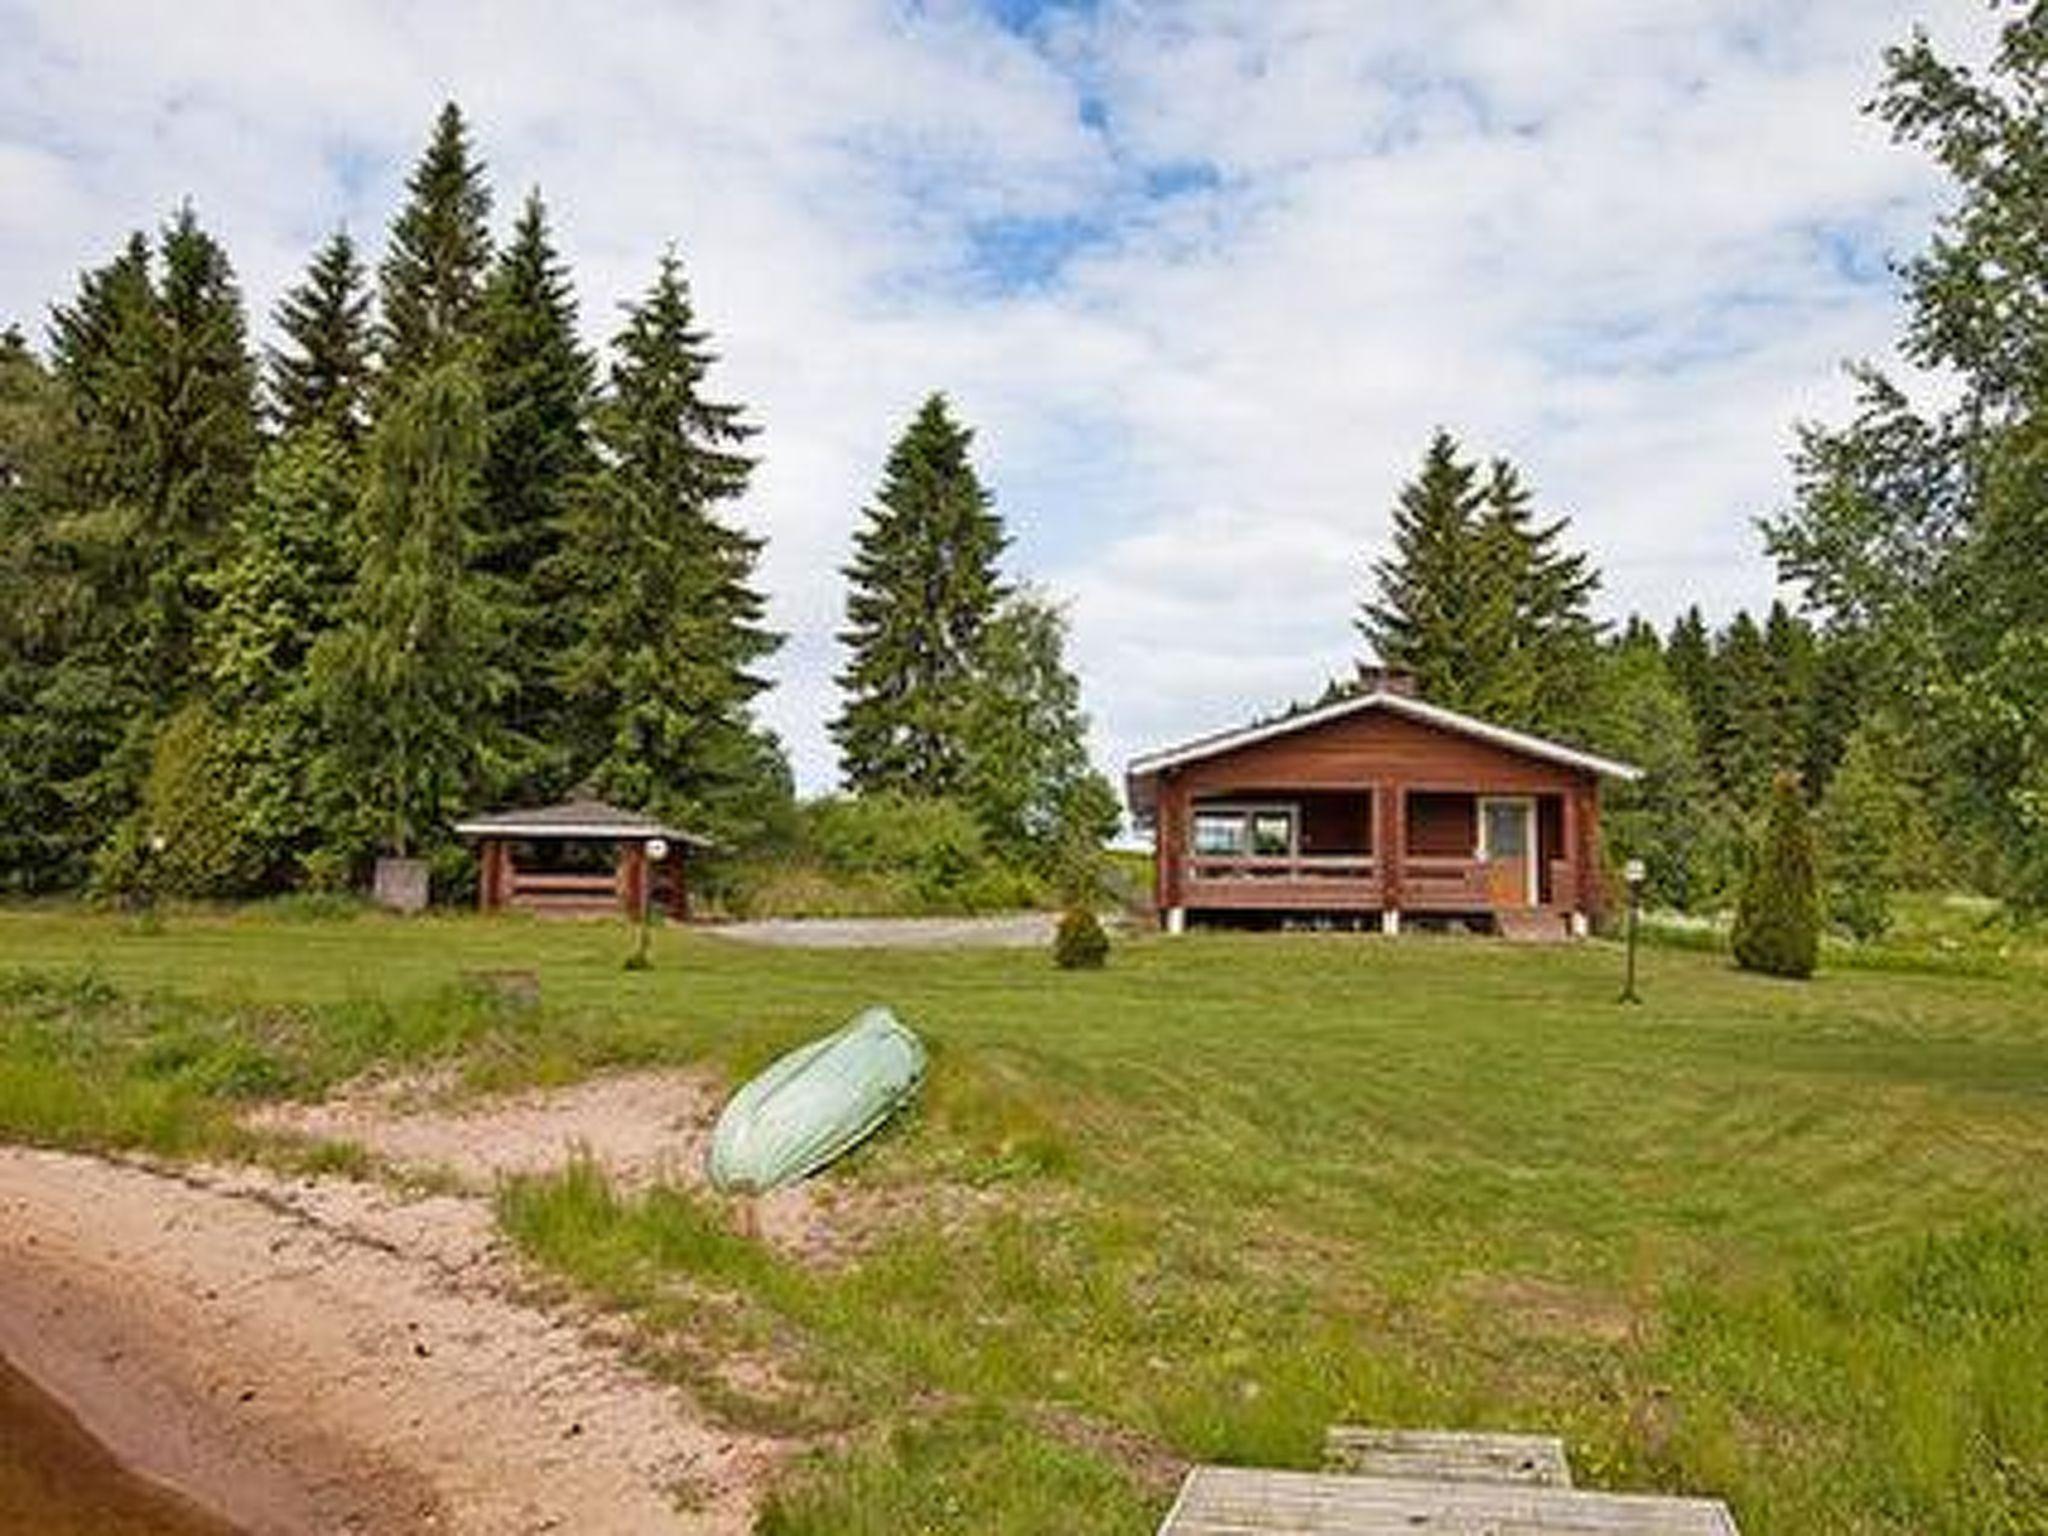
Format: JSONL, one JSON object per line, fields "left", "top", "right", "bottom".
{"left": 1128, "top": 678, "right": 1638, "bottom": 934}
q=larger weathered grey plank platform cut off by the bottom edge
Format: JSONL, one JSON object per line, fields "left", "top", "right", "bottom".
{"left": 1159, "top": 1466, "right": 1741, "bottom": 1536}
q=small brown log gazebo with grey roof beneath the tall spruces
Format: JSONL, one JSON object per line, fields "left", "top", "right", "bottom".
{"left": 455, "top": 797, "right": 709, "bottom": 922}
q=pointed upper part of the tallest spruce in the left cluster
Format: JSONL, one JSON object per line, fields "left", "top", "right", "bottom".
{"left": 377, "top": 102, "right": 492, "bottom": 395}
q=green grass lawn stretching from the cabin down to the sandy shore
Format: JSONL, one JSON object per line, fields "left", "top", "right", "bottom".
{"left": 0, "top": 909, "right": 2048, "bottom": 1536}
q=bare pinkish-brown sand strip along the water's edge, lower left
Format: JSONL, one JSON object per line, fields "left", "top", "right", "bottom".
{"left": 0, "top": 1149, "right": 774, "bottom": 1536}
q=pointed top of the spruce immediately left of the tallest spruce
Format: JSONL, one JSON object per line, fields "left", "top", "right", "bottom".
{"left": 266, "top": 229, "right": 371, "bottom": 446}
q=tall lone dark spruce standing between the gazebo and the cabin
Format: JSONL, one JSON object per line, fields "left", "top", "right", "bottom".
{"left": 831, "top": 395, "right": 1008, "bottom": 797}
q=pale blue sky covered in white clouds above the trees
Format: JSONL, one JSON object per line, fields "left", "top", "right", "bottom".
{"left": 0, "top": 0, "right": 1995, "bottom": 788}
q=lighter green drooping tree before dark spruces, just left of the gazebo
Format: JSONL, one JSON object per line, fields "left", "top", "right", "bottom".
{"left": 311, "top": 360, "right": 506, "bottom": 856}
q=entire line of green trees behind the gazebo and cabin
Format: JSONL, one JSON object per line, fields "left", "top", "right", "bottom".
{"left": 0, "top": 4, "right": 2048, "bottom": 934}
